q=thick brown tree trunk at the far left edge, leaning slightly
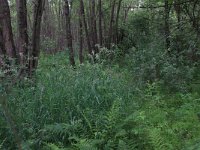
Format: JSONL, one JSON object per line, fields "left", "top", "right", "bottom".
{"left": 0, "top": 0, "right": 16, "bottom": 58}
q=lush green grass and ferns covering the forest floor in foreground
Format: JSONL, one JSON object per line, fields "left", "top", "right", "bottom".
{"left": 0, "top": 53, "right": 200, "bottom": 150}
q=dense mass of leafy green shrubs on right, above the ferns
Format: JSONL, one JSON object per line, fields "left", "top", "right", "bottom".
{"left": 113, "top": 9, "right": 198, "bottom": 92}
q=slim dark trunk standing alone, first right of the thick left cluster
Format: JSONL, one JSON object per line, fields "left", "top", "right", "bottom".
{"left": 65, "top": 0, "right": 75, "bottom": 66}
